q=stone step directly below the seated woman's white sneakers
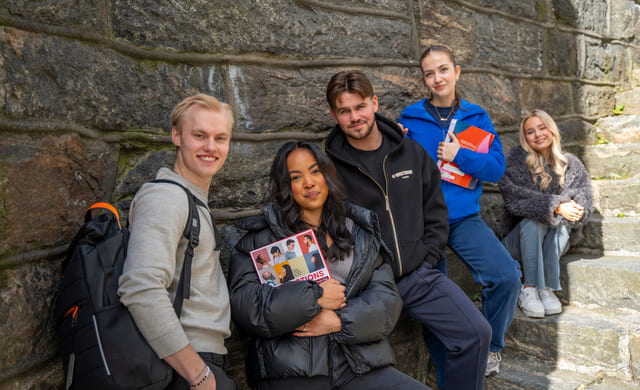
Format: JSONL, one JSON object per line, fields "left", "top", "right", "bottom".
{"left": 505, "top": 305, "right": 640, "bottom": 381}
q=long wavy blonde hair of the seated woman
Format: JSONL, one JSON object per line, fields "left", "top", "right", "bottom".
{"left": 520, "top": 109, "right": 569, "bottom": 191}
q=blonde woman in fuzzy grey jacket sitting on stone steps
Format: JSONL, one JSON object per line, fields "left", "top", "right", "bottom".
{"left": 499, "top": 110, "right": 593, "bottom": 318}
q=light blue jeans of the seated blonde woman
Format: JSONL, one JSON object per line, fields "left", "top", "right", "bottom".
{"left": 502, "top": 218, "right": 571, "bottom": 290}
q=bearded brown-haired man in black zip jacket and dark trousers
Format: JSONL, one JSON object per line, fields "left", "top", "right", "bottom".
{"left": 325, "top": 71, "right": 491, "bottom": 390}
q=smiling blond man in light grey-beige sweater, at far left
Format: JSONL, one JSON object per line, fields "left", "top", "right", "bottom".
{"left": 118, "top": 94, "right": 237, "bottom": 390}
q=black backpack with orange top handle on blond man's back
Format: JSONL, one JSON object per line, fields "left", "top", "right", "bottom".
{"left": 55, "top": 180, "right": 204, "bottom": 390}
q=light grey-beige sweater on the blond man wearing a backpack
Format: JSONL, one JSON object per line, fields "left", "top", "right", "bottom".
{"left": 118, "top": 168, "right": 231, "bottom": 358}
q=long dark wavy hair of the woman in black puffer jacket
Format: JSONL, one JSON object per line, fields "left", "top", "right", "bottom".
{"left": 269, "top": 141, "right": 354, "bottom": 261}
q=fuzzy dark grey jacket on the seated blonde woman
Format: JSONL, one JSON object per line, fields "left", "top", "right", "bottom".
{"left": 499, "top": 146, "right": 593, "bottom": 244}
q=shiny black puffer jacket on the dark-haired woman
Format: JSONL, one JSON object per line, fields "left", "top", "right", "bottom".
{"left": 228, "top": 204, "right": 402, "bottom": 386}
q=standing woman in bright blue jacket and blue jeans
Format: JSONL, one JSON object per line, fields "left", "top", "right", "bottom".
{"left": 400, "top": 46, "right": 521, "bottom": 375}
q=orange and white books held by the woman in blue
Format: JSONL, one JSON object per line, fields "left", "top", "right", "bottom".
{"left": 437, "top": 119, "right": 495, "bottom": 190}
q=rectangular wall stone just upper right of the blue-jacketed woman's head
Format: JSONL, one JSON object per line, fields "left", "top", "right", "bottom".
{"left": 476, "top": 14, "right": 543, "bottom": 73}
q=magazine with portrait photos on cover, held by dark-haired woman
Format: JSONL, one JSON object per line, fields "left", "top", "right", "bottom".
{"left": 250, "top": 229, "right": 331, "bottom": 287}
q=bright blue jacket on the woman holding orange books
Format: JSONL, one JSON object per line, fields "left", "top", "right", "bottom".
{"left": 399, "top": 99, "right": 505, "bottom": 224}
